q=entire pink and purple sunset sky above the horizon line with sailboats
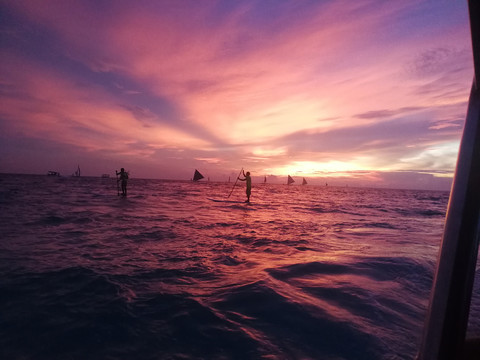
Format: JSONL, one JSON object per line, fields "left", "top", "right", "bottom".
{"left": 0, "top": 0, "right": 473, "bottom": 190}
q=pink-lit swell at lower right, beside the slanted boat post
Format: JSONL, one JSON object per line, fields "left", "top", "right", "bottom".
{"left": 266, "top": 257, "right": 433, "bottom": 358}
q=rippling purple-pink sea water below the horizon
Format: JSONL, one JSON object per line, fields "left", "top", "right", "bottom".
{"left": 0, "top": 174, "right": 480, "bottom": 360}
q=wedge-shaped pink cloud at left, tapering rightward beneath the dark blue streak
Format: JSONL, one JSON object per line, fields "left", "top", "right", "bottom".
{"left": 0, "top": 54, "right": 208, "bottom": 154}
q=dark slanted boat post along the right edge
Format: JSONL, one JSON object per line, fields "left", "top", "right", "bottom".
{"left": 417, "top": 0, "right": 480, "bottom": 360}
